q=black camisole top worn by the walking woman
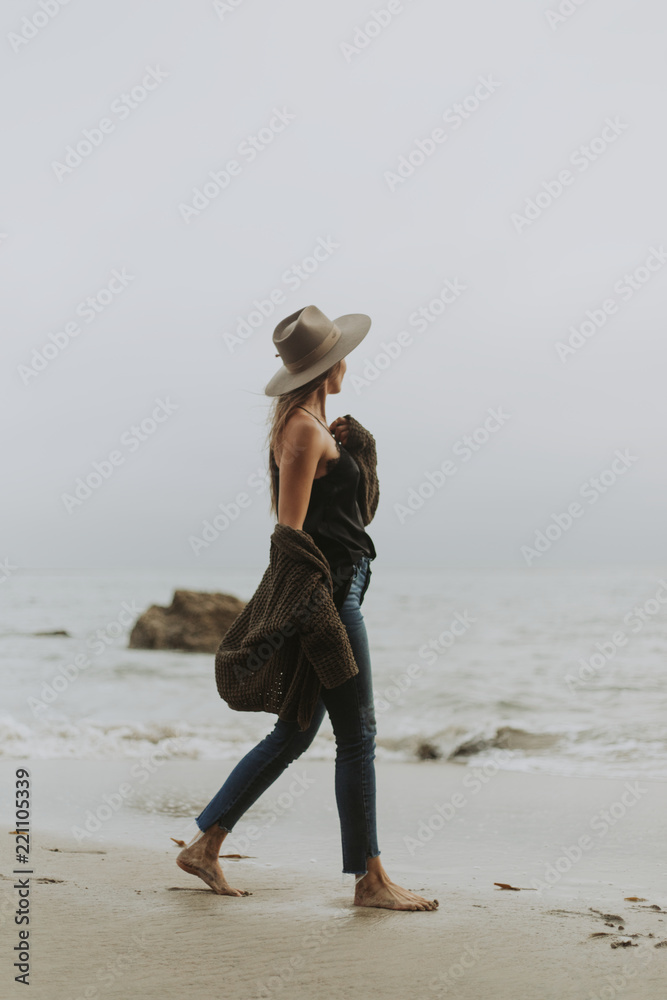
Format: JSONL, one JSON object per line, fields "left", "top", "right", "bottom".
{"left": 271, "top": 411, "right": 377, "bottom": 608}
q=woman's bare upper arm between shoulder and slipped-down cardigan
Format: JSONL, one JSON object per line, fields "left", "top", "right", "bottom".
{"left": 278, "top": 419, "right": 322, "bottom": 531}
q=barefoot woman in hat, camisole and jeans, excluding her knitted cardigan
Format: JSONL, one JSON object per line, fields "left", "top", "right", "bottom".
{"left": 177, "top": 306, "right": 438, "bottom": 910}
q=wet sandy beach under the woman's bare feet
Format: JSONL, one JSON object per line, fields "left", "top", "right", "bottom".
{"left": 0, "top": 758, "right": 667, "bottom": 1000}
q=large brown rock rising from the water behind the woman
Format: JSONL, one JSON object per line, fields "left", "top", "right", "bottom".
{"left": 129, "top": 590, "right": 245, "bottom": 653}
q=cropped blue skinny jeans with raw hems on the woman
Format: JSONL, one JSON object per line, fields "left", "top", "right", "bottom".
{"left": 196, "top": 556, "right": 380, "bottom": 875}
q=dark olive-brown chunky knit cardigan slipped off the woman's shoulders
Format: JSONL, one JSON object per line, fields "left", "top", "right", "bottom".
{"left": 215, "top": 413, "right": 380, "bottom": 730}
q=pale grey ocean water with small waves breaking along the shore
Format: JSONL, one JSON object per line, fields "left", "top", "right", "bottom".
{"left": 0, "top": 560, "right": 667, "bottom": 780}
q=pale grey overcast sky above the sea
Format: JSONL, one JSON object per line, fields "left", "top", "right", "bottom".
{"left": 0, "top": 0, "right": 667, "bottom": 572}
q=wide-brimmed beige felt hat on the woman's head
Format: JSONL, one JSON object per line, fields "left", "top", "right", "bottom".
{"left": 264, "top": 306, "right": 371, "bottom": 396}
